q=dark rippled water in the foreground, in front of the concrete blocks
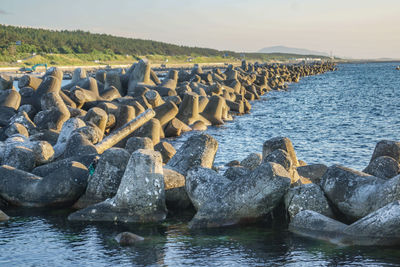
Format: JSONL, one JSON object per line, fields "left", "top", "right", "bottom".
{"left": 0, "top": 209, "right": 400, "bottom": 266}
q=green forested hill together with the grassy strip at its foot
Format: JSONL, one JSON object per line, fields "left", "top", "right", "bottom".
{"left": 0, "top": 25, "right": 328, "bottom": 65}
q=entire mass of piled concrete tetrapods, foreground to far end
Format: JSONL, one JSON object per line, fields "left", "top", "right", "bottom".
{"left": 0, "top": 60, "right": 400, "bottom": 249}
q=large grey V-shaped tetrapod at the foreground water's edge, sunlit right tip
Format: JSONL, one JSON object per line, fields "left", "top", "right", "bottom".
{"left": 186, "top": 162, "right": 290, "bottom": 228}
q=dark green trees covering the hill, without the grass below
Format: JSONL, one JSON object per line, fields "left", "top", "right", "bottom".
{"left": 0, "top": 24, "right": 328, "bottom": 60}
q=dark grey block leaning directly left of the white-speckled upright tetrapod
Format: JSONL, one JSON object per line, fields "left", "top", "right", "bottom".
{"left": 74, "top": 148, "right": 130, "bottom": 209}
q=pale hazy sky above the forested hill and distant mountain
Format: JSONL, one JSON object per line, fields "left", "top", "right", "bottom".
{"left": 0, "top": 0, "right": 400, "bottom": 58}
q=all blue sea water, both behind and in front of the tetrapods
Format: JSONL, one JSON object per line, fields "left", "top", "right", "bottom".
{"left": 0, "top": 64, "right": 400, "bottom": 266}
